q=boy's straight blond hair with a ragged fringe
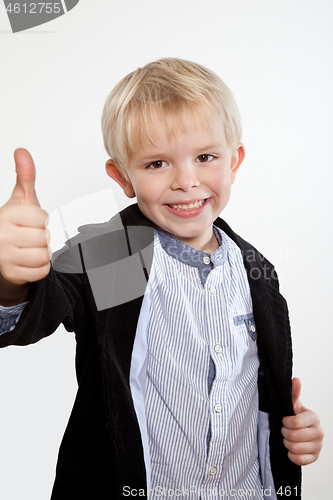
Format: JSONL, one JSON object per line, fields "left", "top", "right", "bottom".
{"left": 102, "top": 58, "right": 242, "bottom": 174}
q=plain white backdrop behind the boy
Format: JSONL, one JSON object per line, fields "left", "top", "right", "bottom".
{"left": 0, "top": 0, "right": 333, "bottom": 500}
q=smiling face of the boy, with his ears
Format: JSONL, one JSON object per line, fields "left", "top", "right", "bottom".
{"left": 106, "top": 114, "right": 245, "bottom": 251}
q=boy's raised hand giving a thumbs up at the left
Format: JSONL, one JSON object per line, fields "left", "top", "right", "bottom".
{"left": 0, "top": 149, "right": 50, "bottom": 305}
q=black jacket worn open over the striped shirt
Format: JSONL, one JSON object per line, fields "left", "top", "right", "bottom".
{"left": 0, "top": 205, "right": 301, "bottom": 500}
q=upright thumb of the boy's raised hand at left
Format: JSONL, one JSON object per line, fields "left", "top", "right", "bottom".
{"left": 11, "top": 148, "right": 40, "bottom": 206}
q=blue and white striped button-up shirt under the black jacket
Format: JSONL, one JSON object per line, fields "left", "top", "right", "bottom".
{"left": 146, "top": 228, "right": 262, "bottom": 500}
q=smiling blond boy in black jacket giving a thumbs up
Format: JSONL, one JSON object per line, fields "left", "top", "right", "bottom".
{"left": 0, "top": 59, "right": 323, "bottom": 500}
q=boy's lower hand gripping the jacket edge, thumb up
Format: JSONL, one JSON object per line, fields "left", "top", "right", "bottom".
{"left": 281, "top": 378, "right": 324, "bottom": 465}
